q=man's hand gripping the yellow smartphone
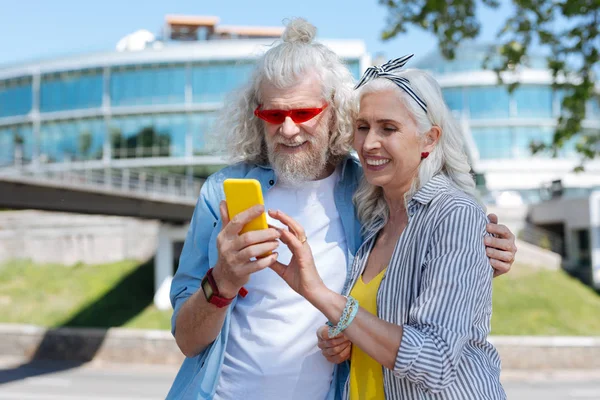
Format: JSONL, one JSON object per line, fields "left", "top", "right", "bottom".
{"left": 213, "top": 201, "right": 280, "bottom": 298}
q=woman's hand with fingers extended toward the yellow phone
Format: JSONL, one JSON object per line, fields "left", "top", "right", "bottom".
{"left": 269, "top": 210, "right": 328, "bottom": 302}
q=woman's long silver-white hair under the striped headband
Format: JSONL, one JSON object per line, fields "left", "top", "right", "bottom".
{"left": 354, "top": 69, "right": 479, "bottom": 232}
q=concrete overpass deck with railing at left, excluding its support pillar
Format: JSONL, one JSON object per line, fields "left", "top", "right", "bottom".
{"left": 0, "top": 170, "right": 201, "bottom": 224}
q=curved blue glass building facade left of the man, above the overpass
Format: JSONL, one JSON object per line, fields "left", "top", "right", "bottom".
{"left": 0, "top": 41, "right": 364, "bottom": 167}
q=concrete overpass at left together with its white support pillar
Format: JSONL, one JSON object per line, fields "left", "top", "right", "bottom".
{"left": 0, "top": 169, "right": 204, "bottom": 308}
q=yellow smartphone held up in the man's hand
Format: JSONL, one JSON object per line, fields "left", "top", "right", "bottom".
{"left": 223, "top": 179, "right": 269, "bottom": 234}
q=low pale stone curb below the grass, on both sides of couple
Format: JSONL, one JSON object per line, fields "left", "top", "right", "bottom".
{"left": 0, "top": 324, "right": 600, "bottom": 371}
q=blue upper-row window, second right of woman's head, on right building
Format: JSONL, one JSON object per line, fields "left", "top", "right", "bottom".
{"left": 465, "top": 86, "right": 509, "bottom": 119}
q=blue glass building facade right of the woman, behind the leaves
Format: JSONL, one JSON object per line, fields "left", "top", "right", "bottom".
{"left": 416, "top": 43, "right": 600, "bottom": 202}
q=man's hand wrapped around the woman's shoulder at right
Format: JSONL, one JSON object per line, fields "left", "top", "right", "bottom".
{"left": 484, "top": 214, "right": 517, "bottom": 277}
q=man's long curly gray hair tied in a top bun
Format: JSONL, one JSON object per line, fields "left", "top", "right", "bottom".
{"left": 213, "top": 18, "right": 354, "bottom": 165}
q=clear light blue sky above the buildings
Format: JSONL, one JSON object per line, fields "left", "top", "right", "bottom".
{"left": 0, "top": 0, "right": 510, "bottom": 66}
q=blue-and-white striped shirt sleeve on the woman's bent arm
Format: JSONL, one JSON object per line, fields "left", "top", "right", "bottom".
{"left": 394, "top": 203, "right": 493, "bottom": 393}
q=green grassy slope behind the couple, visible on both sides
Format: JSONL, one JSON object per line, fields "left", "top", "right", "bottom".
{"left": 0, "top": 261, "right": 600, "bottom": 336}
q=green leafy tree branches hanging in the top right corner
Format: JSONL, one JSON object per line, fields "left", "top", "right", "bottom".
{"left": 379, "top": 0, "right": 600, "bottom": 169}
